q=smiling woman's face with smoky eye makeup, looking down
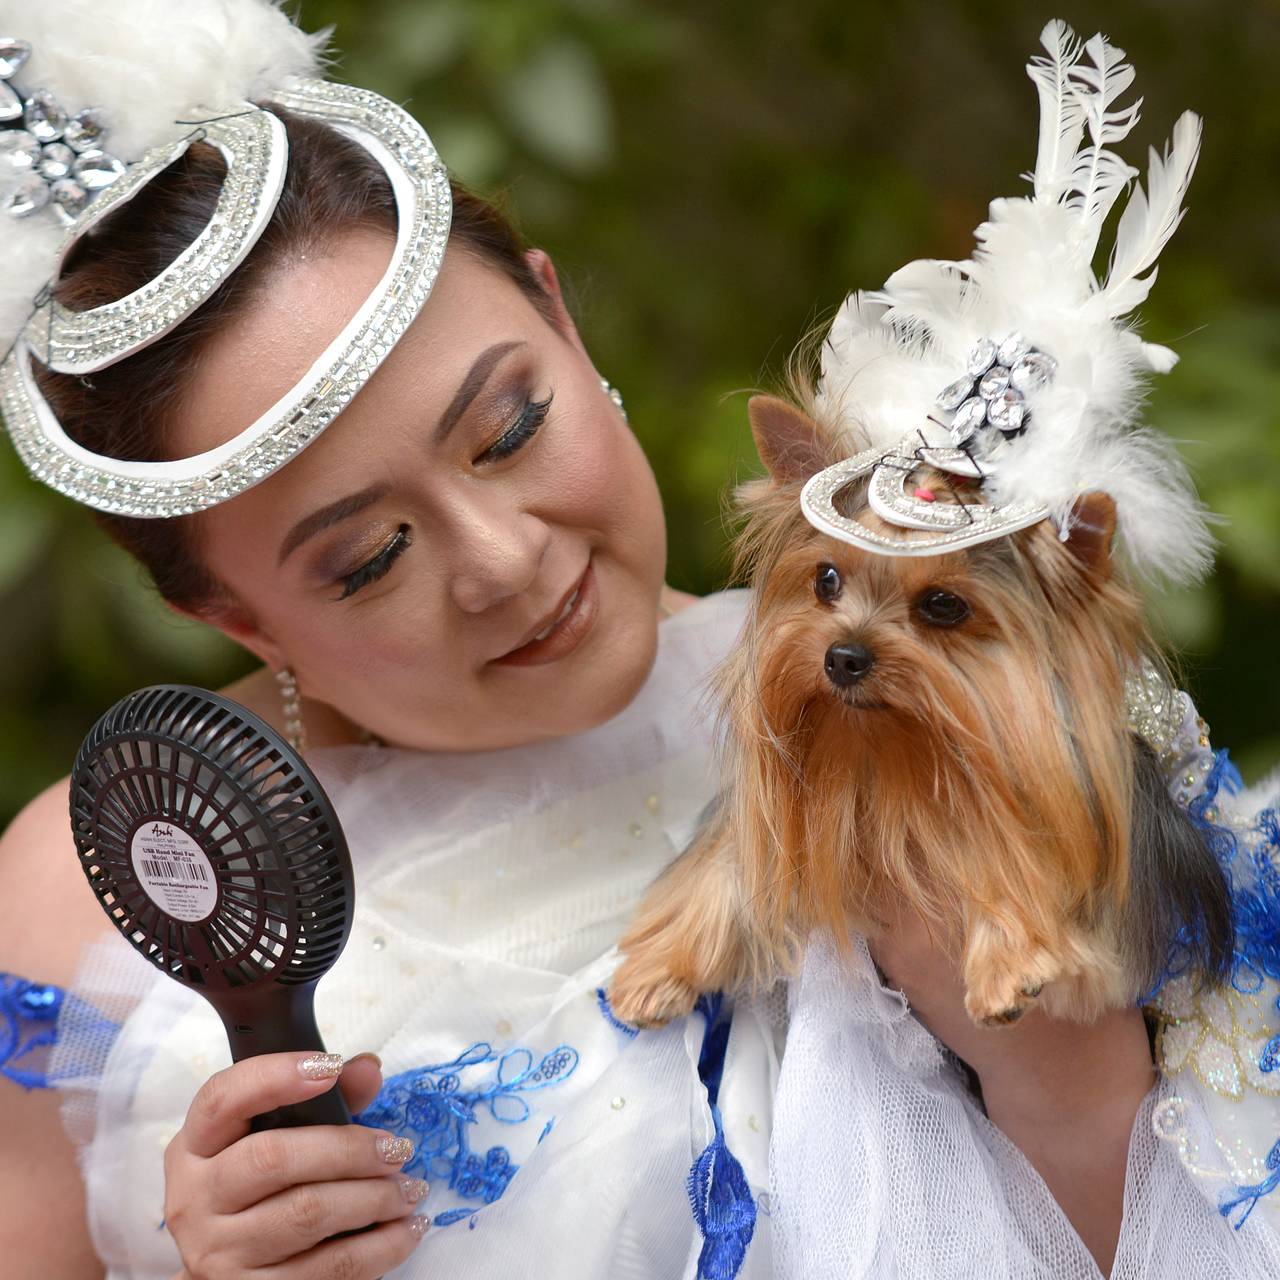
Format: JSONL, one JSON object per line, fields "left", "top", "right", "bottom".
{"left": 177, "top": 232, "right": 666, "bottom": 750}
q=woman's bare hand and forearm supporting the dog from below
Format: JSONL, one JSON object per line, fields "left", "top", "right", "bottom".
{"left": 868, "top": 913, "right": 1156, "bottom": 1275}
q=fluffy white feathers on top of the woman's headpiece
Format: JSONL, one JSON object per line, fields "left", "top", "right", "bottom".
{"left": 0, "top": 0, "right": 328, "bottom": 355}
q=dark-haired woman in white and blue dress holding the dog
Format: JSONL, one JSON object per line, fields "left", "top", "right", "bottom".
{"left": 0, "top": 2, "right": 1259, "bottom": 1280}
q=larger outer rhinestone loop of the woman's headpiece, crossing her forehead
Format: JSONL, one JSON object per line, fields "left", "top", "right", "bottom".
{"left": 0, "top": 79, "right": 452, "bottom": 518}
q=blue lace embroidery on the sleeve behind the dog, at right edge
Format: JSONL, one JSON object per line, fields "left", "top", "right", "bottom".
{"left": 1151, "top": 751, "right": 1280, "bottom": 1230}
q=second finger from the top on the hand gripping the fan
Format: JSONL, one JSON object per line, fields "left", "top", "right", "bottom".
{"left": 206, "top": 1124, "right": 413, "bottom": 1213}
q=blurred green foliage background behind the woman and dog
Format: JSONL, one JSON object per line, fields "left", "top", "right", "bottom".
{"left": 0, "top": 0, "right": 1280, "bottom": 822}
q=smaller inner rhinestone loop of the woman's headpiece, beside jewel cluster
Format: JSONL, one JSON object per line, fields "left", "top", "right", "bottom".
{"left": 23, "top": 102, "right": 289, "bottom": 374}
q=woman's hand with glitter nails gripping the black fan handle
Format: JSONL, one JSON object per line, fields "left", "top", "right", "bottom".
{"left": 165, "top": 1053, "right": 428, "bottom": 1280}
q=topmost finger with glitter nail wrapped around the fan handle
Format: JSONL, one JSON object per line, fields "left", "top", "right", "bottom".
{"left": 178, "top": 1053, "right": 343, "bottom": 1157}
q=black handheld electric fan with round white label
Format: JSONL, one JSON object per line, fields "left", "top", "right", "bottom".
{"left": 70, "top": 685, "right": 353, "bottom": 1129}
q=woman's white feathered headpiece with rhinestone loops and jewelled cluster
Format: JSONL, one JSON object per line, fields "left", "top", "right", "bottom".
{"left": 0, "top": 0, "right": 452, "bottom": 517}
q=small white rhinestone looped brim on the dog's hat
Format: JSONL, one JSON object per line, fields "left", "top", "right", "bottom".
{"left": 800, "top": 435, "right": 1050, "bottom": 556}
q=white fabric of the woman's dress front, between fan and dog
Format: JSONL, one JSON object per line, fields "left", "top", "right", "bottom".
{"left": 61, "top": 591, "right": 778, "bottom": 1280}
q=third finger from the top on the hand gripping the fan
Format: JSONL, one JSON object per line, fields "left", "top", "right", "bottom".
{"left": 236, "top": 1174, "right": 426, "bottom": 1266}
